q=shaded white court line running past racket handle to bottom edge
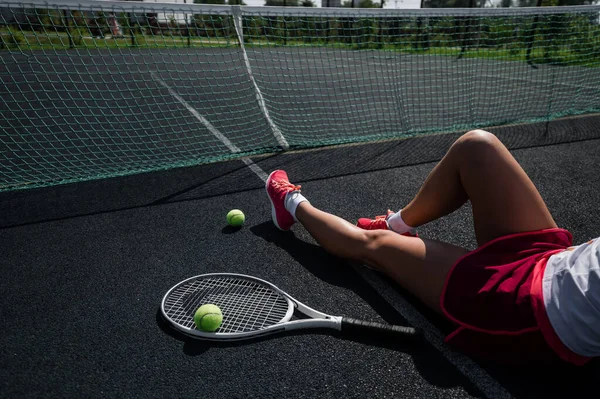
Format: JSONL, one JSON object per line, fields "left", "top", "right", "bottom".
{"left": 354, "top": 266, "right": 513, "bottom": 399}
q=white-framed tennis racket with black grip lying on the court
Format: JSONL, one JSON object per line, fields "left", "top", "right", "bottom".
{"left": 161, "top": 273, "right": 420, "bottom": 341}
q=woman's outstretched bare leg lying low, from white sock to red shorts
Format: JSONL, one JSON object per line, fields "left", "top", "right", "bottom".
{"left": 296, "top": 202, "right": 468, "bottom": 312}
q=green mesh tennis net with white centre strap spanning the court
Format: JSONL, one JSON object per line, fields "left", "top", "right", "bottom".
{"left": 0, "top": 0, "right": 600, "bottom": 190}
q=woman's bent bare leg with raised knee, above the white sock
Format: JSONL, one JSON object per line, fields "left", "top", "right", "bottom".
{"left": 402, "top": 130, "right": 556, "bottom": 245}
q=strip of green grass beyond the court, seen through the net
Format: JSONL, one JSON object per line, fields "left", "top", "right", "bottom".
{"left": 0, "top": 27, "right": 600, "bottom": 68}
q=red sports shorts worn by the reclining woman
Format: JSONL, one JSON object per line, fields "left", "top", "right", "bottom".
{"left": 440, "top": 229, "right": 590, "bottom": 365}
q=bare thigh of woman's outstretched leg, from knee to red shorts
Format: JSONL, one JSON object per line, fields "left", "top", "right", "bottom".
{"left": 364, "top": 230, "right": 469, "bottom": 313}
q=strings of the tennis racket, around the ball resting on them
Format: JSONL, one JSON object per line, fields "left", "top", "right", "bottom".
{"left": 164, "top": 277, "right": 290, "bottom": 333}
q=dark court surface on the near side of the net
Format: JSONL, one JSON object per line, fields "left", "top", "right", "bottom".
{"left": 0, "top": 116, "right": 600, "bottom": 398}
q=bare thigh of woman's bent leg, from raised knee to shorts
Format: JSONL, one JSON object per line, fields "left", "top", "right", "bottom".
{"left": 460, "top": 131, "right": 556, "bottom": 245}
